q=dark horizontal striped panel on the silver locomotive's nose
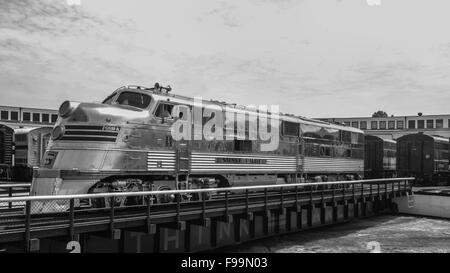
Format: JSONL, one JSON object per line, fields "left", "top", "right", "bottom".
{"left": 61, "top": 125, "right": 119, "bottom": 142}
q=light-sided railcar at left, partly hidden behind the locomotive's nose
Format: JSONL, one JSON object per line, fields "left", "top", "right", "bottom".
{"left": 13, "top": 127, "right": 52, "bottom": 181}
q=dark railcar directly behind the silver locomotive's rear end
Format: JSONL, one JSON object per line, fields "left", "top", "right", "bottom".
{"left": 364, "top": 135, "right": 397, "bottom": 178}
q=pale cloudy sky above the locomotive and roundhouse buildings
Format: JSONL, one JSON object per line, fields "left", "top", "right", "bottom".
{"left": 0, "top": 0, "right": 450, "bottom": 117}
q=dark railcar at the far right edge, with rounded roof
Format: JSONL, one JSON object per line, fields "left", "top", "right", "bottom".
{"left": 397, "top": 133, "right": 449, "bottom": 186}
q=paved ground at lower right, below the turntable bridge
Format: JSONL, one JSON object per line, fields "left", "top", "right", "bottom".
{"left": 222, "top": 212, "right": 450, "bottom": 253}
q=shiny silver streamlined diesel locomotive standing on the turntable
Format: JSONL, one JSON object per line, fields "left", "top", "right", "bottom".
{"left": 31, "top": 84, "right": 364, "bottom": 208}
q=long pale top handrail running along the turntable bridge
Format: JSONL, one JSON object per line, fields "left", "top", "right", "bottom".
{"left": 0, "top": 177, "right": 415, "bottom": 202}
